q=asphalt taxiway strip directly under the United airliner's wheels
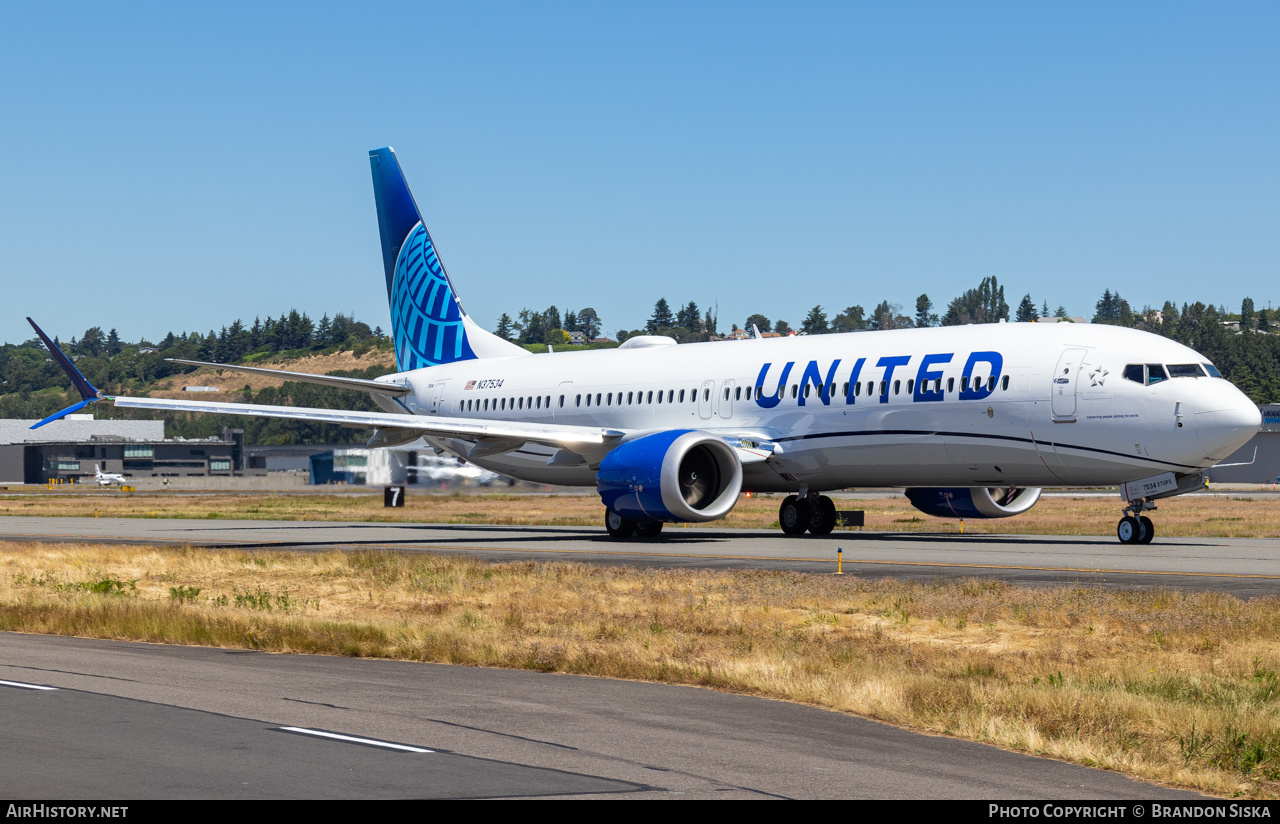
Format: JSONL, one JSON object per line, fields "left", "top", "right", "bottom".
{"left": 0, "top": 516, "right": 1280, "bottom": 596}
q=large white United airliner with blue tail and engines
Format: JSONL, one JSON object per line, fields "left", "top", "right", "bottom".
{"left": 28, "top": 148, "right": 1262, "bottom": 543}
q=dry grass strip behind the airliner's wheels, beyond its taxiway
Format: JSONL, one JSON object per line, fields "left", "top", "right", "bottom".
{"left": 0, "top": 489, "right": 1280, "bottom": 537}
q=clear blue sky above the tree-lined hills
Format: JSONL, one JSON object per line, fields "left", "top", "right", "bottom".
{"left": 0, "top": 1, "right": 1280, "bottom": 342}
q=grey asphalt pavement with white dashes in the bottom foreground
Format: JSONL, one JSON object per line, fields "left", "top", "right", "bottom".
{"left": 0, "top": 633, "right": 1194, "bottom": 800}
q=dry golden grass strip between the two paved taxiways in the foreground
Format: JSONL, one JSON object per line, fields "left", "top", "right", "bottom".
{"left": 0, "top": 544, "right": 1280, "bottom": 797}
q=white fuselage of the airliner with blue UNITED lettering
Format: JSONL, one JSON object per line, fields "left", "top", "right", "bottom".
{"left": 379, "top": 324, "right": 1261, "bottom": 491}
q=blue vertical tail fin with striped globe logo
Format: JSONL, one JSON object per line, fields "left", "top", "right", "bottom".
{"left": 369, "top": 147, "right": 527, "bottom": 372}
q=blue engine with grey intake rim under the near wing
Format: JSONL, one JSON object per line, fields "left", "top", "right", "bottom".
{"left": 595, "top": 430, "right": 742, "bottom": 522}
